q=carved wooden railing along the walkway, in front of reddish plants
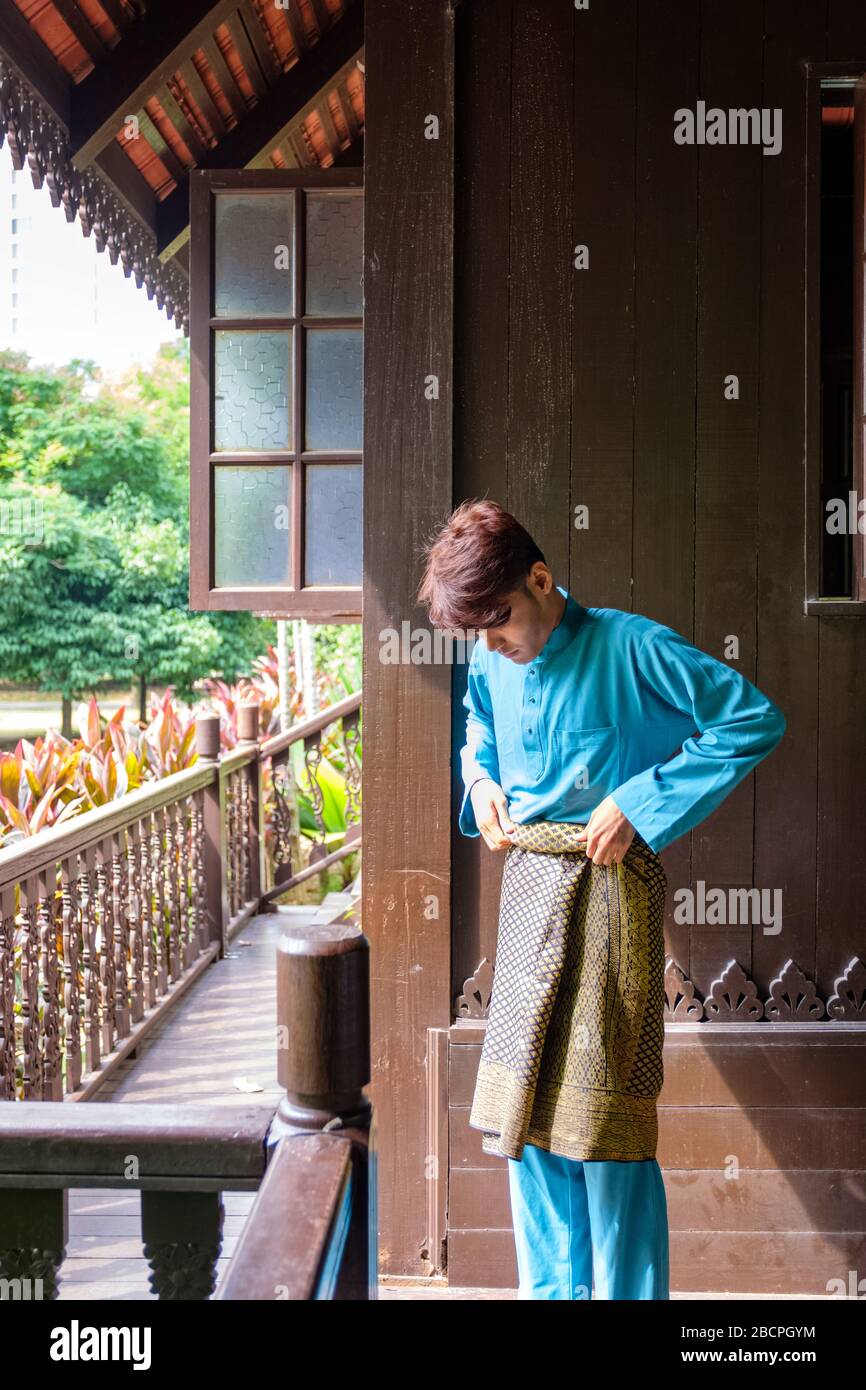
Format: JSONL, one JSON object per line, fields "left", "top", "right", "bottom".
{"left": 0, "top": 694, "right": 361, "bottom": 1102}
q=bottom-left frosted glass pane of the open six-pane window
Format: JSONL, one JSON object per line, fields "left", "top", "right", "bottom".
{"left": 214, "top": 463, "right": 292, "bottom": 588}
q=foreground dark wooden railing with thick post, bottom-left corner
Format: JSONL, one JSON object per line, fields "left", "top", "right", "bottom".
{"left": 0, "top": 923, "right": 378, "bottom": 1301}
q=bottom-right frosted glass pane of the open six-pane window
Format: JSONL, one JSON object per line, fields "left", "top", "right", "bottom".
{"left": 304, "top": 463, "right": 361, "bottom": 584}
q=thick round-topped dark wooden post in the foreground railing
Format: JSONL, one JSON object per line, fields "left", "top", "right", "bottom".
{"left": 267, "top": 923, "right": 378, "bottom": 1300}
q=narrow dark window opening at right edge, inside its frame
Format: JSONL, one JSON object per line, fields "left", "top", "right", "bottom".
{"left": 806, "top": 68, "right": 866, "bottom": 616}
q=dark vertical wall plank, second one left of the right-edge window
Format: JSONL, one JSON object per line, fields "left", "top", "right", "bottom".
{"left": 686, "top": 0, "right": 769, "bottom": 987}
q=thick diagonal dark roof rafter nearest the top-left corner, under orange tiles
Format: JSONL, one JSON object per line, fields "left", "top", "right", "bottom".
{"left": 70, "top": 0, "right": 238, "bottom": 168}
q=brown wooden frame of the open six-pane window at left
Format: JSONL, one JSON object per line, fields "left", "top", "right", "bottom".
{"left": 189, "top": 168, "right": 364, "bottom": 623}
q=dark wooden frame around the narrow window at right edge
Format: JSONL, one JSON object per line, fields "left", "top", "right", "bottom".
{"left": 803, "top": 63, "right": 866, "bottom": 617}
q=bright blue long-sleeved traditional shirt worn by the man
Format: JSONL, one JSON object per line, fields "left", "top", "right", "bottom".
{"left": 459, "top": 585, "right": 785, "bottom": 852}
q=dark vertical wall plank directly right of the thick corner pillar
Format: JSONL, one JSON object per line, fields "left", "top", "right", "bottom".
{"left": 450, "top": 0, "right": 513, "bottom": 1005}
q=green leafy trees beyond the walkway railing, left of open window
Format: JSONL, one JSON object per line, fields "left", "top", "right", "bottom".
{"left": 0, "top": 343, "right": 274, "bottom": 699}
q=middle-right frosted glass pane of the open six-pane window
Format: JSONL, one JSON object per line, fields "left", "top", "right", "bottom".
{"left": 306, "top": 328, "right": 361, "bottom": 449}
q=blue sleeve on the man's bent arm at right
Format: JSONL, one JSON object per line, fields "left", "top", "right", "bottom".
{"left": 612, "top": 627, "right": 785, "bottom": 852}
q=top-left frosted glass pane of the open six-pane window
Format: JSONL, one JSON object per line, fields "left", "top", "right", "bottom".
{"left": 214, "top": 193, "right": 293, "bottom": 318}
